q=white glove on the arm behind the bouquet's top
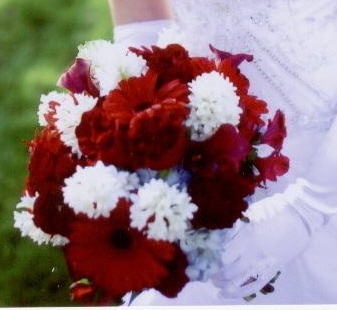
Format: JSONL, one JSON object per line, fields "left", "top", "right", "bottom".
{"left": 114, "top": 19, "right": 172, "bottom": 47}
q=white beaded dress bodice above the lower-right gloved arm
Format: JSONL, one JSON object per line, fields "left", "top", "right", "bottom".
{"left": 165, "top": 0, "right": 337, "bottom": 196}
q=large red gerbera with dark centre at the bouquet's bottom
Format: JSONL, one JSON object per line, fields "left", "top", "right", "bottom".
{"left": 65, "top": 200, "right": 188, "bottom": 301}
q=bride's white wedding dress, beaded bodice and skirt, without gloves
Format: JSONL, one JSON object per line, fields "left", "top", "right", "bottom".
{"left": 115, "top": 0, "right": 337, "bottom": 305}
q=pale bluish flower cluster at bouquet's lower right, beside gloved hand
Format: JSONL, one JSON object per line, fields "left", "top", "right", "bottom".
{"left": 180, "top": 229, "right": 224, "bottom": 281}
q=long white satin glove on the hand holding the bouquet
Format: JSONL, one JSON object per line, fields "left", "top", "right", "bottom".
{"left": 212, "top": 115, "right": 337, "bottom": 297}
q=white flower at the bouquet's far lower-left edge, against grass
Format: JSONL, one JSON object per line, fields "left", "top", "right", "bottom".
{"left": 14, "top": 193, "right": 69, "bottom": 246}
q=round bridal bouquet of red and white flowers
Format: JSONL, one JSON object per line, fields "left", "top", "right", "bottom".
{"left": 14, "top": 41, "right": 289, "bottom": 304}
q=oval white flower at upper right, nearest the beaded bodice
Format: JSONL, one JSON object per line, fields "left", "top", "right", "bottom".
{"left": 186, "top": 71, "right": 242, "bottom": 141}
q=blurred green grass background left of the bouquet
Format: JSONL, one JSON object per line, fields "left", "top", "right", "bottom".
{"left": 0, "top": 0, "right": 112, "bottom": 307}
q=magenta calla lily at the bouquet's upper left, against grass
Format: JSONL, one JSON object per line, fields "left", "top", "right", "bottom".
{"left": 57, "top": 58, "right": 99, "bottom": 97}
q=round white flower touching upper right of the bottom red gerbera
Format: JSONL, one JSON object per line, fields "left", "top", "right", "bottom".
{"left": 130, "top": 179, "right": 197, "bottom": 242}
